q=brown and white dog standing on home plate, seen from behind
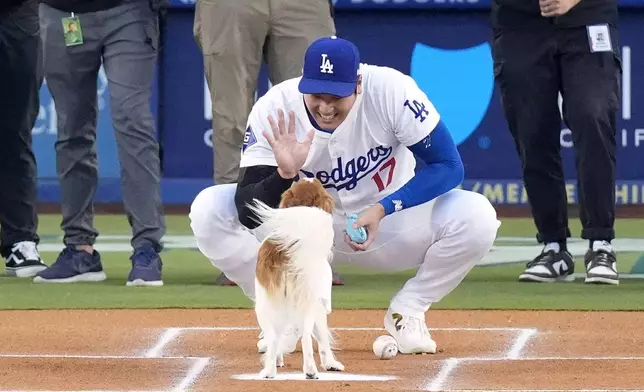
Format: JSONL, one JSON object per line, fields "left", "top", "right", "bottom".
{"left": 250, "top": 179, "right": 344, "bottom": 379}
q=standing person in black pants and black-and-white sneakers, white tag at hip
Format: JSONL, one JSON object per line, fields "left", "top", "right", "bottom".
{"left": 491, "top": 0, "right": 621, "bottom": 284}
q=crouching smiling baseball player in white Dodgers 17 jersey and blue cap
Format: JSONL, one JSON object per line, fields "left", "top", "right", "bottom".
{"left": 190, "top": 36, "right": 499, "bottom": 354}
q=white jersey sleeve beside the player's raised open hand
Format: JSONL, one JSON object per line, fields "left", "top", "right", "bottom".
{"left": 239, "top": 100, "right": 277, "bottom": 167}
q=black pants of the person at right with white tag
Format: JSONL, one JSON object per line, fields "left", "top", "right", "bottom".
{"left": 492, "top": 27, "right": 621, "bottom": 243}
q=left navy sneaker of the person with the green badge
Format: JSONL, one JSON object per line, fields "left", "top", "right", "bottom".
{"left": 34, "top": 246, "right": 107, "bottom": 283}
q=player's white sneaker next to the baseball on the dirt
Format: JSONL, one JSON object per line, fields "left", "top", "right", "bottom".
{"left": 385, "top": 309, "right": 436, "bottom": 354}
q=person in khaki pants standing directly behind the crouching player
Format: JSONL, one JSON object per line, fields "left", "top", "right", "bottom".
{"left": 194, "top": 0, "right": 342, "bottom": 285}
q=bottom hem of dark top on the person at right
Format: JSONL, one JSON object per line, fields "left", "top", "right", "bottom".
{"left": 491, "top": 0, "right": 618, "bottom": 29}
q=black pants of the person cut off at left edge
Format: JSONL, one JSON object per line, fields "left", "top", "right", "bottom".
{"left": 0, "top": 0, "right": 42, "bottom": 257}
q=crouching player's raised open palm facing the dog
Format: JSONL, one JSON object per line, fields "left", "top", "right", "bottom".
{"left": 263, "top": 109, "right": 315, "bottom": 178}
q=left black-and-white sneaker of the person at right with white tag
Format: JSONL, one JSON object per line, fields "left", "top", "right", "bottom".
{"left": 519, "top": 250, "right": 575, "bottom": 282}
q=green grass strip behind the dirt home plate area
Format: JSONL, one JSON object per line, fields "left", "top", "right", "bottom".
{"left": 0, "top": 216, "right": 644, "bottom": 310}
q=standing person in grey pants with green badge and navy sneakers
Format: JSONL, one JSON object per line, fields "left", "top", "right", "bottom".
{"left": 34, "top": 0, "right": 165, "bottom": 286}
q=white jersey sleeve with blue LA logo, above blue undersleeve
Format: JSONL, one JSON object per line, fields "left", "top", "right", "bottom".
{"left": 385, "top": 71, "right": 440, "bottom": 147}
